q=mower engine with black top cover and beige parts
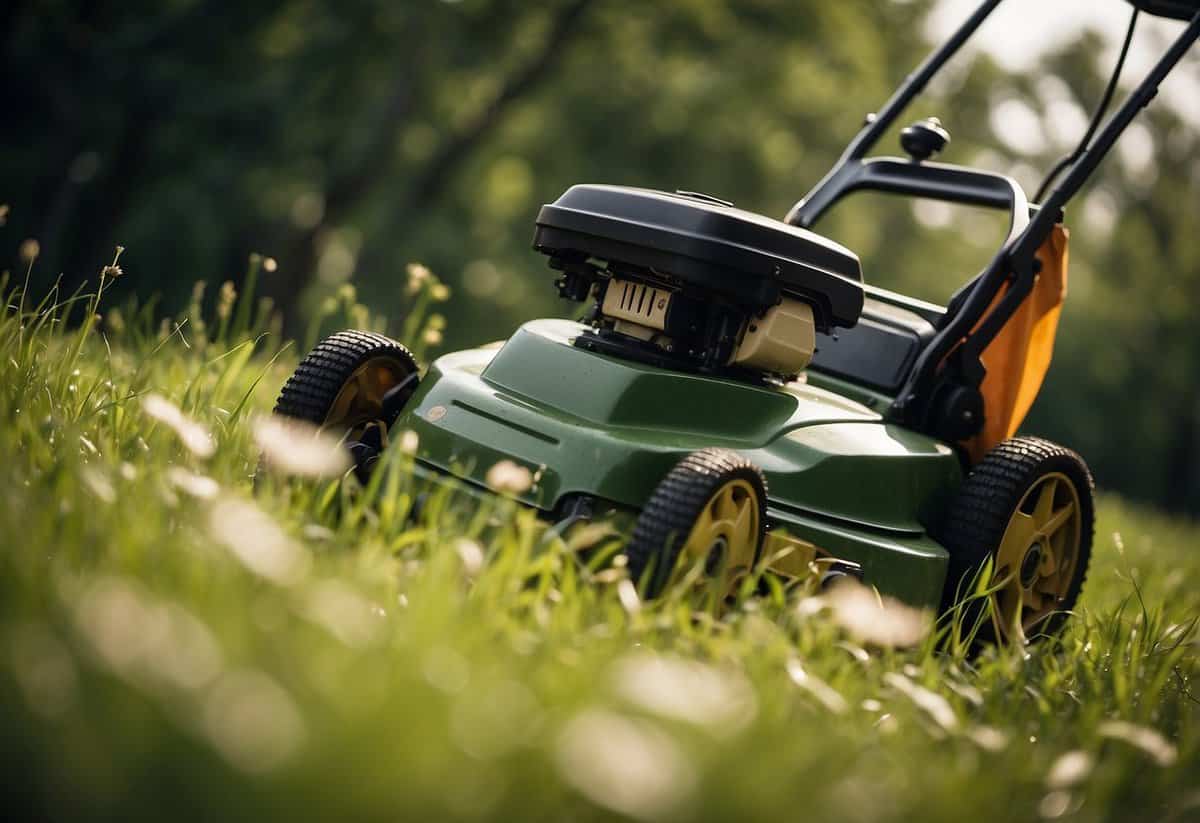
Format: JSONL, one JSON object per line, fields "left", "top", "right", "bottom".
{"left": 534, "top": 186, "right": 863, "bottom": 380}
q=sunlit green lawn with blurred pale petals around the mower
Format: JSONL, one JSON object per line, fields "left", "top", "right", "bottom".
{"left": 0, "top": 260, "right": 1200, "bottom": 822}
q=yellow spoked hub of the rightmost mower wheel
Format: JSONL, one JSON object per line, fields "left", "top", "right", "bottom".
{"left": 992, "top": 471, "right": 1082, "bottom": 637}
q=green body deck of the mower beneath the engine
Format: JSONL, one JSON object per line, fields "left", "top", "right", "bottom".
{"left": 396, "top": 320, "right": 961, "bottom": 605}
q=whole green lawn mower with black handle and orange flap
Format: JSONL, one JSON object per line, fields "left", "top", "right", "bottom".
{"left": 275, "top": 0, "right": 1200, "bottom": 641}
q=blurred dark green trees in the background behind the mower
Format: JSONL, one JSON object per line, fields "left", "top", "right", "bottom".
{"left": 0, "top": 0, "right": 1200, "bottom": 516}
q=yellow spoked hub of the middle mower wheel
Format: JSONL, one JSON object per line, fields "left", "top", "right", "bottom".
{"left": 676, "top": 480, "right": 762, "bottom": 595}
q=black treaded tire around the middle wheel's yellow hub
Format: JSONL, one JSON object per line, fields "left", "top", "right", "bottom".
{"left": 625, "top": 449, "right": 767, "bottom": 597}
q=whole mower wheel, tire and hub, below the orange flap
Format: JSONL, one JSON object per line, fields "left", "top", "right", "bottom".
{"left": 940, "top": 437, "right": 1096, "bottom": 642}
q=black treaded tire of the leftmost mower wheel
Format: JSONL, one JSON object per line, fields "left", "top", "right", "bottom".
{"left": 275, "top": 331, "right": 418, "bottom": 426}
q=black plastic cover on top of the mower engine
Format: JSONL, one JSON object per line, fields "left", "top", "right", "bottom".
{"left": 533, "top": 185, "right": 863, "bottom": 329}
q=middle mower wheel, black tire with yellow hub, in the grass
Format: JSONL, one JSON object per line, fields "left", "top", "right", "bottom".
{"left": 625, "top": 449, "right": 767, "bottom": 597}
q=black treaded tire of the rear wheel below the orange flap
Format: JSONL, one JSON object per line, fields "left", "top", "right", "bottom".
{"left": 937, "top": 437, "right": 1096, "bottom": 642}
